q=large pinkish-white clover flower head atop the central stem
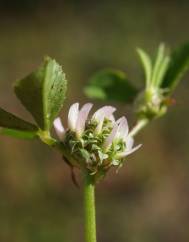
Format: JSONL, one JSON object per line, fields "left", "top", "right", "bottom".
{"left": 54, "top": 103, "right": 140, "bottom": 181}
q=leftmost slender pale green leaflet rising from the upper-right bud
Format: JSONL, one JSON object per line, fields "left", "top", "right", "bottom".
{"left": 137, "top": 48, "right": 152, "bottom": 87}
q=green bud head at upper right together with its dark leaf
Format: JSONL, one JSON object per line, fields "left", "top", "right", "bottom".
{"left": 135, "top": 44, "right": 186, "bottom": 120}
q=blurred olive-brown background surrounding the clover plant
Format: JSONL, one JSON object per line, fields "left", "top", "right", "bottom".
{"left": 0, "top": 0, "right": 189, "bottom": 242}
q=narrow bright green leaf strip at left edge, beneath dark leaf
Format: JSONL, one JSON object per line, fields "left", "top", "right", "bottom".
{"left": 0, "top": 128, "right": 37, "bottom": 139}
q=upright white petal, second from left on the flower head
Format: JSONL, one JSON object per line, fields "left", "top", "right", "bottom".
{"left": 68, "top": 103, "right": 79, "bottom": 131}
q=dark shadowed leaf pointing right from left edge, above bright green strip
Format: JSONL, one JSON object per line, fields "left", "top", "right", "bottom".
{"left": 0, "top": 108, "right": 38, "bottom": 131}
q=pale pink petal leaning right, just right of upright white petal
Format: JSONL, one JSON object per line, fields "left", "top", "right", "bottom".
{"left": 76, "top": 103, "right": 93, "bottom": 136}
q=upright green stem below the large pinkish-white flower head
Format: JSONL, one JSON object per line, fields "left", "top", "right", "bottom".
{"left": 84, "top": 175, "right": 96, "bottom": 242}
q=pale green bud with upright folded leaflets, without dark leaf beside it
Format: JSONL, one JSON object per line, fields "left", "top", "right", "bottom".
{"left": 135, "top": 44, "right": 171, "bottom": 120}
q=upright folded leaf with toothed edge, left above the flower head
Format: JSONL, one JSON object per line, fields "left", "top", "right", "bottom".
{"left": 15, "top": 57, "right": 67, "bottom": 130}
